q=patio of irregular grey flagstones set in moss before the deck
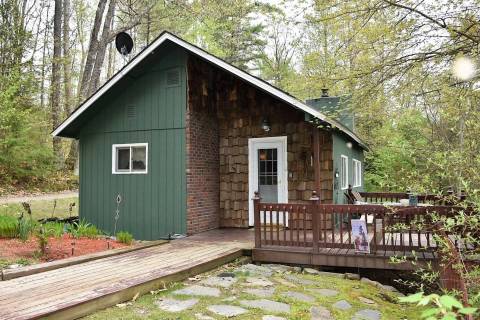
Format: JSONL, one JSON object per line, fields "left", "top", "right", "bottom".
{"left": 148, "top": 264, "right": 406, "bottom": 320}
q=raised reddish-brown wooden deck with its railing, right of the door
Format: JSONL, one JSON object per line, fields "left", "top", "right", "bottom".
{"left": 252, "top": 199, "right": 474, "bottom": 270}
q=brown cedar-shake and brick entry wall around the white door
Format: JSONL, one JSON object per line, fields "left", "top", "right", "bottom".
{"left": 187, "top": 55, "right": 333, "bottom": 232}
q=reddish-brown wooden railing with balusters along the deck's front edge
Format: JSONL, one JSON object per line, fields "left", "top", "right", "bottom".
{"left": 254, "top": 195, "right": 462, "bottom": 253}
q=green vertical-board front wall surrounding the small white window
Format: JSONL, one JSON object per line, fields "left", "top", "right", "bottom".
{"left": 79, "top": 46, "right": 187, "bottom": 240}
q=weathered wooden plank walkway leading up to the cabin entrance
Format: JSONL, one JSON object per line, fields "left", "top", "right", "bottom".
{"left": 0, "top": 229, "right": 253, "bottom": 319}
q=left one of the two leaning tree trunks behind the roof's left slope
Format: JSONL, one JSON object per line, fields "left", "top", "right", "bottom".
{"left": 79, "top": 0, "right": 107, "bottom": 101}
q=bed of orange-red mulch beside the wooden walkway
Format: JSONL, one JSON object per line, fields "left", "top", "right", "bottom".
{"left": 0, "top": 234, "right": 127, "bottom": 261}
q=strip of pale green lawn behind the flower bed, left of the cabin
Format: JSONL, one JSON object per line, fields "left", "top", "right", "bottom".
{"left": 0, "top": 197, "right": 78, "bottom": 220}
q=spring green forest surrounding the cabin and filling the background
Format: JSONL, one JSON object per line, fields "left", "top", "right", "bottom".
{"left": 0, "top": 0, "right": 480, "bottom": 194}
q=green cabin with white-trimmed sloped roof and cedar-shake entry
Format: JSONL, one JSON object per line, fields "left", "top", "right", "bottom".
{"left": 53, "top": 32, "right": 366, "bottom": 240}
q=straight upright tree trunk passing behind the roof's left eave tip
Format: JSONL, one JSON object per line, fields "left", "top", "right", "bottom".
{"left": 51, "top": 0, "right": 63, "bottom": 169}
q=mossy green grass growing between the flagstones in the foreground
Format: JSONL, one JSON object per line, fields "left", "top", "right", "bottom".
{"left": 85, "top": 264, "right": 419, "bottom": 320}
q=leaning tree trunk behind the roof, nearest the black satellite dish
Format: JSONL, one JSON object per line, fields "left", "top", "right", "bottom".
{"left": 88, "top": 0, "right": 116, "bottom": 96}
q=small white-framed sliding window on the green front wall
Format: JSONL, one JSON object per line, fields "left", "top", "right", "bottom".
{"left": 112, "top": 143, "right": 148, "bottom": 174}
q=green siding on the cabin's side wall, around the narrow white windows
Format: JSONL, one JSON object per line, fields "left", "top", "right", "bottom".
{"left": 333, "top": 132, "right": 365, "bottom": 204}
